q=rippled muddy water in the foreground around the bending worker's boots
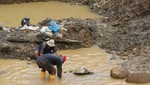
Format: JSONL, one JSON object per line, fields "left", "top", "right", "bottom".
{"left": 0, "top": 47, "right": 150, "bottom": 85}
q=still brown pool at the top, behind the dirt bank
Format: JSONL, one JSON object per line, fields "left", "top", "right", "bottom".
{"left": 0, "top": 1, "right": 100, "bottom": 27}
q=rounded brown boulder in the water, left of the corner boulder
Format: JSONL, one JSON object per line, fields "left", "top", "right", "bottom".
{"left": 110, "top": 67, "right": 129, "bottom": 79}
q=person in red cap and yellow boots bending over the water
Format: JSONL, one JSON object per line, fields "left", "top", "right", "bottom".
{"left": 36, "top": 54, "right": 66, "bottom": 78}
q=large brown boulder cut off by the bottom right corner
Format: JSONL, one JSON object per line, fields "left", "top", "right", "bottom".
{"left": 126, "top": 73, "right": 150, "bottom": 83}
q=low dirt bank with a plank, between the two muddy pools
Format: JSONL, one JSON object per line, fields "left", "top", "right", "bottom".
{"left": 0, "top": 18, "right": 97, "bottom": 59}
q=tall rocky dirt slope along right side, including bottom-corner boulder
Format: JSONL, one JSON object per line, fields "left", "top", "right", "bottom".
{"left": 60, "top": 0, "right": 150, "bottom": 83}
